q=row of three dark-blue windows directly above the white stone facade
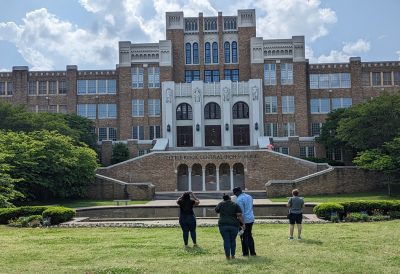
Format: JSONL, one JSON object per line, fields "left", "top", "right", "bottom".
{"left": 185, "top": 69, "right": 239, "bottom": 83}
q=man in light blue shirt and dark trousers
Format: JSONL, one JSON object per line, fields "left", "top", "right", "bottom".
{"left": 233, "top": 187, "right": 257, "bottom": 256}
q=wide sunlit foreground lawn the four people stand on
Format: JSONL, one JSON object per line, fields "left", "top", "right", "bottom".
{"left": 0, "top": 220, "right": 400, "bottom": 273}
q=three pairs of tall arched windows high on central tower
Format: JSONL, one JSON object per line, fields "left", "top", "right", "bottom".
{"left": 185, "top": 41, "right": 238, "bottom": 65}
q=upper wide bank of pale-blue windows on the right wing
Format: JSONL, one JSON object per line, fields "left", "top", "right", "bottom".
{"left": 310, "top": 73, "right": 351, "bottom": 89}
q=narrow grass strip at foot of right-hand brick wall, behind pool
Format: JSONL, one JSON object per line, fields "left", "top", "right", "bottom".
{"left": 269, "top": 192, "right": 400, "bottom": 203}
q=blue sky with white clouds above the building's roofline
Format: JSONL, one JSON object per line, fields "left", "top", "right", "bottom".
{"left": 0, "top": 0, "right": 400, "bottom": 71}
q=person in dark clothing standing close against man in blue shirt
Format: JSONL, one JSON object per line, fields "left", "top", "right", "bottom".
{"left": 215, "top": 194, "right": 245, "bottom": 260}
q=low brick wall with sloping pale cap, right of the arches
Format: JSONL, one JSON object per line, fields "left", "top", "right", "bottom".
{"left": 266, "top": 167, "right": 384, "bottom": 197}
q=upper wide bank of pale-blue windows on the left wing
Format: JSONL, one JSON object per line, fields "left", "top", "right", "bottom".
{"left": 76, "top": 80, "right": 117, "bottom": 95}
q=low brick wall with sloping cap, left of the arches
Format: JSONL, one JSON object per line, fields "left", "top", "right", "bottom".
{"left": 88, "top": 174, "right": 155, "bottom": 200}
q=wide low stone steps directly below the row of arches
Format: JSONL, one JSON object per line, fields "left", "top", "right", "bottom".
{"left": 154, "top": 190, "right": 267, "bottom": 200}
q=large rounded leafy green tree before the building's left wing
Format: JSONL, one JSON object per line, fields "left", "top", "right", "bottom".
{"left": 0, "top": 130, "right": 98, "bottom": 199}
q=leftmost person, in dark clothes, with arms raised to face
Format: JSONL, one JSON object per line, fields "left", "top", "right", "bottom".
{"left": 176, "top": 192, "right": 200, "bottom": 247}
